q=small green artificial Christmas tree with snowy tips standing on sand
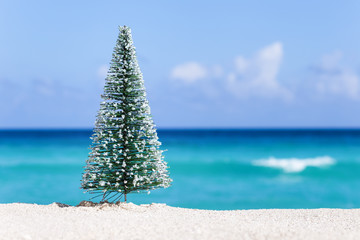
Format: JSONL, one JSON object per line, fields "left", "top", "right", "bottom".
{"left": 81, "top": 26, "right": 172, "bottom": 202}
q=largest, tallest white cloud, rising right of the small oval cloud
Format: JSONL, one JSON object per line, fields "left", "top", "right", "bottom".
{"left": 227, "top": 42, "right": 293, "bottom": 100}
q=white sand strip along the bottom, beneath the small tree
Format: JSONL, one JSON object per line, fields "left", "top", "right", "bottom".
{"left": 0, "top": 203, "right": 360, "bottom": 240}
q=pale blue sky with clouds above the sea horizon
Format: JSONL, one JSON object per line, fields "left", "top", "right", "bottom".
{"left": 0, "top": 0, "right": 360, "bottom": 128}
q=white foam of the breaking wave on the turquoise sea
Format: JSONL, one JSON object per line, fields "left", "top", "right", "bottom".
{"left": 252, "top": 156, "right": 336, "bottom": 172}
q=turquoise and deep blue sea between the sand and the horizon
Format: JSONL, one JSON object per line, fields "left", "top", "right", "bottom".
{"left": 0, "top": 129, "right": 360, "bottom": 210}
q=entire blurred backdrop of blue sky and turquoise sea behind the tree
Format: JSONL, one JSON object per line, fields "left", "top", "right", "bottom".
{"left": 0, "top": 0, "right": 360, "bottom": 209}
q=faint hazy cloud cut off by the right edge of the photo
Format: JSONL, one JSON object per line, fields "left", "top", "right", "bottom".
{"left": 315, "top": 51, "right": 360, "bottom": 99}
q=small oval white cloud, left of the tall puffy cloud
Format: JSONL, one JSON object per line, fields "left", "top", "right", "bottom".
{"left": 171, "top": 62, "right": 208, "bottom": 83}
